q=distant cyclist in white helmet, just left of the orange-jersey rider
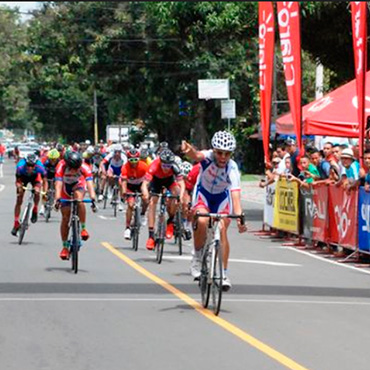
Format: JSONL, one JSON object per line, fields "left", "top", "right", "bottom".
{"left": 99, "top": 144, "right": 127, "bottom": 200}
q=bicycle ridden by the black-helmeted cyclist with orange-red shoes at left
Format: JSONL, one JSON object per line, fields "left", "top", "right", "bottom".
{"left": 60, "top": 199, "right": 97, "bottom": 274}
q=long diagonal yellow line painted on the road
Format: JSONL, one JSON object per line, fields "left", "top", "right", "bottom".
{"left": 102, "top": 242, "right": 308, "bottom": 370}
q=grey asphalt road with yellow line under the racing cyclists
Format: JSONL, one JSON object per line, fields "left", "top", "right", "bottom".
{"left": 0, "top": 161, "right": 370, "bottom": 370}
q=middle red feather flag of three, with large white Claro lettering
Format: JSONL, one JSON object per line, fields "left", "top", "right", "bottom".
{"left": 277, "top": 1, "right": 304, "bottom": 154}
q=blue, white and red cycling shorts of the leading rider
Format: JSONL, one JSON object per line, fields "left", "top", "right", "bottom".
{"left": 192, "top": 186, "right": 232, "bottom": 214}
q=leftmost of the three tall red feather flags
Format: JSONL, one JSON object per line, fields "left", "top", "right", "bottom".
{"left": 258, "top": 1, "right": 275, "bottom": 162}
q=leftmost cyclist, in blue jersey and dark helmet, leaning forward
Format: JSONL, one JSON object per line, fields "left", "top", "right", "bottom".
{"left": 11, "top": 154, "right": 47, "bottom": 236}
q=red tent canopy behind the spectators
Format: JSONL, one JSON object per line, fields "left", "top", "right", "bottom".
{"left": 276, "top": 71, "right": 370, "bottom": 137}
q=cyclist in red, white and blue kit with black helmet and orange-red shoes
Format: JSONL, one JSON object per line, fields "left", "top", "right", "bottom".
{"left": 55, "top": 151, "right": 95, "bottom": 260}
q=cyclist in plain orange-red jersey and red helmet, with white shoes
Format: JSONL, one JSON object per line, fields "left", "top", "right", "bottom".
{"left": 121, "top": 149, "right": 149, "bottom": 240}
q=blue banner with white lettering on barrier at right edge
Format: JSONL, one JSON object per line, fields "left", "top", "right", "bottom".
{"left": 358, "top": 187, "right": 370, "bottom": 252}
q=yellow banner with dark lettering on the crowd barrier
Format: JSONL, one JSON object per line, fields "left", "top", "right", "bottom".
{"left": 273, "top": 178, "right": 299, "bottom": 233}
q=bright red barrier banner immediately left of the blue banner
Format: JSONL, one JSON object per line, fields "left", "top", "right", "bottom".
{"left": 329, "top": 186, "right": 358, "bottom": 249}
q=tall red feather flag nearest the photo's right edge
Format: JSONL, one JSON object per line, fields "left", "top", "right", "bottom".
{"left": 351, "top": 1, "right": 367, "bottom": 166}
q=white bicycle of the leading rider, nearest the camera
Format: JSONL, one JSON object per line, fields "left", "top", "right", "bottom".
{"left": 194, "top": 212, "right": 245, "bottom": 316}
